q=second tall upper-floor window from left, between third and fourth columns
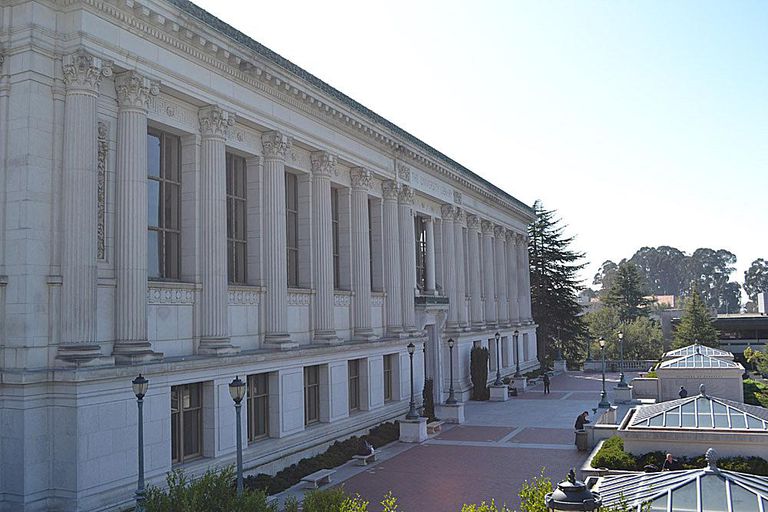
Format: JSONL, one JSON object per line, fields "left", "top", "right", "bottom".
{"left": 227, "top": 153, "right": 248, "bottom": 284}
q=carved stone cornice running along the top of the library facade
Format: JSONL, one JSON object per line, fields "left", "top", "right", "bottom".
{"left": 67, "top": 0, "right": 534, "bottom": 220}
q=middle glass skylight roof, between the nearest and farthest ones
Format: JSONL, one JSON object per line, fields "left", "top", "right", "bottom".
{"left": 629, "top": 394, "right": 768, "bottom": 430}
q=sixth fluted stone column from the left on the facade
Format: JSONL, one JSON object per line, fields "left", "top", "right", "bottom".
{"left": 349, "top": 167, "right": 375, "bottom": 340}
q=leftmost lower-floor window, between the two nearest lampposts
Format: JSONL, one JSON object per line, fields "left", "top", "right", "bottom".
{"left": 171, "top": 382, "right": 203, "bottom": 464}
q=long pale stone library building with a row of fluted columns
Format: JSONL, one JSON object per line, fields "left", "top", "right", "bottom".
{"left": 0, "top": 0, "right": 538, "bottom": 511}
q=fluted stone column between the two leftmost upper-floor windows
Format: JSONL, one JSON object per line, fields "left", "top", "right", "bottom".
{"left": 198, "top": 105, "right": 239, "bottom": 355}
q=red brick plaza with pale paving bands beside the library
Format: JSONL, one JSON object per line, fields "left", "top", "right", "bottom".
{"left": 337, "top": 373, "right": 632, "bottom": 512}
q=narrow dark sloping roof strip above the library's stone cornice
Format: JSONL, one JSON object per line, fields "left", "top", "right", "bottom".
{"left": 162, "top": 0, "right": 533, "bottom": 215}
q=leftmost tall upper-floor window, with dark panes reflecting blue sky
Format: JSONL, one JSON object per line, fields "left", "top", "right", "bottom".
{"left": 147, "top": 130, "right": 181, "bottom": 279}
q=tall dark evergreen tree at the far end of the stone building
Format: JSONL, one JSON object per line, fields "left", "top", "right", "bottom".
{"left": 528, "top": 201, "right": 586, "bottom": 362}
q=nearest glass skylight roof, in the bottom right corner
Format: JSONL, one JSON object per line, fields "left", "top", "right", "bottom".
{"left": 593, "top": 462, "right": 768, "bottom": 512}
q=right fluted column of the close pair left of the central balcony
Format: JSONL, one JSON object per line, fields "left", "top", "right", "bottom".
{"left": 398, "top": 185, "right": 416, "bottom": 332}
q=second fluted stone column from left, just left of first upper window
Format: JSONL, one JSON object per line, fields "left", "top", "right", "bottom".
{"left": 112, "top": 71, "right": 162, "bottom": 364}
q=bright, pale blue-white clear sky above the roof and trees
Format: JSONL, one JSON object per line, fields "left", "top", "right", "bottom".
{"left": 190, "top": 0, "right": 768, "bottom": 288}
